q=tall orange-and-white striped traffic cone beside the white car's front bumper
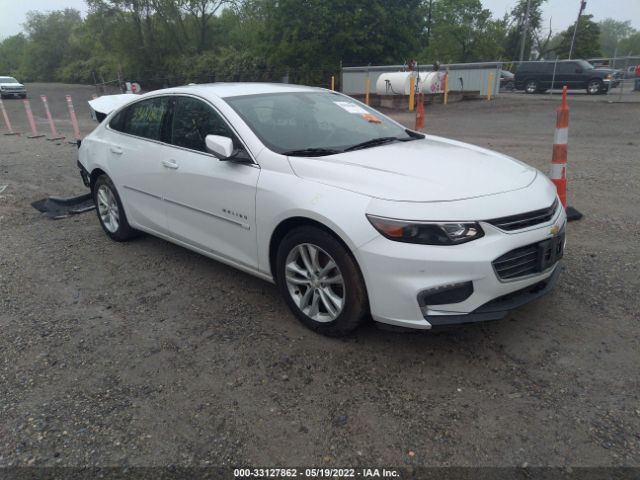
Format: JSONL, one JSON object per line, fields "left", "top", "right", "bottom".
{"left": 549, "top": 86, "right": 582, "bottom": 221}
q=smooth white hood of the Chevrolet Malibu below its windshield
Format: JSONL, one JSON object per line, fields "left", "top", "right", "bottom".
{"left": 289, "top": 136, "right": 537, "bottom": 202}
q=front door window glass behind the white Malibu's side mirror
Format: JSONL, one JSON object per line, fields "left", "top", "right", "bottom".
{"left": 171, "top": 97, "right": 241, "bottom": 152}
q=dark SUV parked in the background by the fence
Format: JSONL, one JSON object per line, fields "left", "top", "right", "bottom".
{"left": 515, "top": 60, "right": 620, "bottom": 95}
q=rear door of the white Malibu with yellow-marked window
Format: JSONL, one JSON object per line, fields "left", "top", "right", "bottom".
{"left": 108, "top": 96, "right": 170, "bottom": 233}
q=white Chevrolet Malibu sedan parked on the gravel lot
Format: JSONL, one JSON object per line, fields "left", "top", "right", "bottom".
{"left": 79, "top": 83, "right": 566, "bottom": 335}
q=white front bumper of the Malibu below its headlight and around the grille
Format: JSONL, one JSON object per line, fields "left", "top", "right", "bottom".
{"left": 355, "top": 208, "right": 566, "bottom": 329}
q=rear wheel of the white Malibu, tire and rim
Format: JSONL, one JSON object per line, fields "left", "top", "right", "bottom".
{"left": 92, "top": 174, "right": 138, "bottom": 242}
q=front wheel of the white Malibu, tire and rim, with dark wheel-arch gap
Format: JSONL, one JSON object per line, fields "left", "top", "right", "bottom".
{"left": 276, "top": 226, "right": 369, "bottom": 337}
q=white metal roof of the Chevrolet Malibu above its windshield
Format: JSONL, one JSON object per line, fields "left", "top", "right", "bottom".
{"left": 150, "top": 82, "right": 325, "bottom": 98}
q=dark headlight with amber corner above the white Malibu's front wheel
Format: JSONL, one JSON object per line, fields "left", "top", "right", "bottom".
{"left": 367, "top": 215, "right": 484, "bottom": 245}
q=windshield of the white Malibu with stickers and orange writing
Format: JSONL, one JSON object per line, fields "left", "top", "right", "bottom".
{"left": 225, "top": 92, "right": 422, "bottom": 156}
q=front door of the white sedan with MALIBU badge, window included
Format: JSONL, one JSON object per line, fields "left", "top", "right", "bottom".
{"left": 165, "top": 96, "right": 260, "bottom": 268}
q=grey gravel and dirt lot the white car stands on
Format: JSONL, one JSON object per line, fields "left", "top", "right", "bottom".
{"left": 0, "top": 85, "right": 640, "bottom": 467}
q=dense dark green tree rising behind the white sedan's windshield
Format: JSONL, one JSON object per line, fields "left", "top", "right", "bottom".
{"left": 252, "top": 0, "right": 422, "bottom": 69}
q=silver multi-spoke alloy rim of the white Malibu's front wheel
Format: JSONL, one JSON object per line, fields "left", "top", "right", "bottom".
{"left": 285, "top": 243, "right": 346, "bottom": 323}
